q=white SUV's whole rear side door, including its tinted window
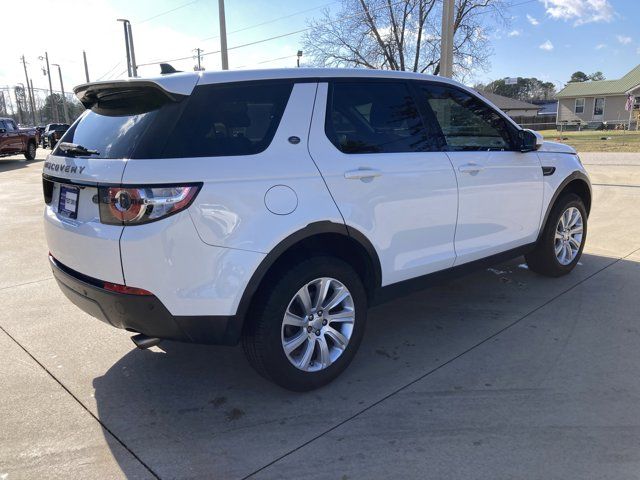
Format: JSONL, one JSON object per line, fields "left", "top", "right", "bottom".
{"left": 309, "top": 79, "right": 458, "bottom": 285}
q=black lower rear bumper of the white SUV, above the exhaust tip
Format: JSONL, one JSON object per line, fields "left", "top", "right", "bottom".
{"left": 49, "top": 256, "right": 241, "bottom": 345}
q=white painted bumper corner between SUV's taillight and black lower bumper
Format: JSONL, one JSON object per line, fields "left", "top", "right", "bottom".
{"left": 121, "top": 211, "right": 265, "bottom": 315}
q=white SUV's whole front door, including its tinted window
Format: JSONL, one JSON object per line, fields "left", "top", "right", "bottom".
{"left": 412, "top": 83, "right": 543, "bottom": 265}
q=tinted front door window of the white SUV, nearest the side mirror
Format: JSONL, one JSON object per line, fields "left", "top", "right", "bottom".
{"left": 420, "top": 85, "right": 514, "bottom": 151}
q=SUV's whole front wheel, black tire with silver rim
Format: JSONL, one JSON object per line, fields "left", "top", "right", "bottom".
{"left": 525, "top": 193, "right": 587, "bottom": 277}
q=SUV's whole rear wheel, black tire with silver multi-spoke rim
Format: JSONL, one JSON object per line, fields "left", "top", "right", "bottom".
{"left": 243, "top": 256, "right": 367, "bottom": 391}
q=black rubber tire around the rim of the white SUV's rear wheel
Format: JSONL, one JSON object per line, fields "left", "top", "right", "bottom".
{"left": 242, "top": 256, "right": 367, "bottom": 391}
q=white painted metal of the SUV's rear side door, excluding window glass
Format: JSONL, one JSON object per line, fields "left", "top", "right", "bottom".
{"left": 309, "top": 83, "right": 458, "bottom": 285}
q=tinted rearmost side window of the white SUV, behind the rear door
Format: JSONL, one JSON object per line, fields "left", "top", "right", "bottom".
{"left": 162, "top": 82, "right": 293, "bottom": 157}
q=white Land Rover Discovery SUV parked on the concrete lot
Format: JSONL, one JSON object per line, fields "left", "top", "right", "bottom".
{"left": 43, "top": 69, "right": 591, "bottom": 390}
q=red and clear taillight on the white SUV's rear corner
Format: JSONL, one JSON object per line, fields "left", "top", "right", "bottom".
{"left": 98, "top": 184, "right": 201, "bottom": 225}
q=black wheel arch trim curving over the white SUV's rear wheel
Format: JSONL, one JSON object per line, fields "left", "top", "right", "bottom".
{"left": 236, "top": 220, "right": 382, "bottom": 326}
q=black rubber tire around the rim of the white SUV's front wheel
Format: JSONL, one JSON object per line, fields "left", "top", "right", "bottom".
{"left": 525, "top": 193, "right": 587, "bottom": 277}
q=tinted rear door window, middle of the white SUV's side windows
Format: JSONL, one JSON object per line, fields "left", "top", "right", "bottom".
{"left": 325, "top": 82, "right": 432, "bottom": 153}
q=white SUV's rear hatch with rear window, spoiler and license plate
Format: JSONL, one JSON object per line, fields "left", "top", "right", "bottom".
{"left": 43, "top": 75, "right": 197, "bottom": 284}
